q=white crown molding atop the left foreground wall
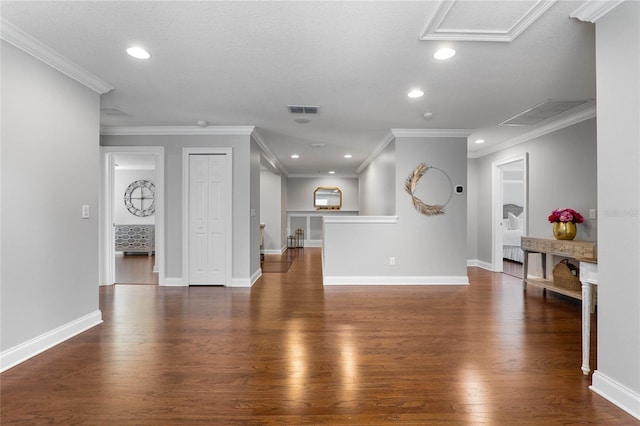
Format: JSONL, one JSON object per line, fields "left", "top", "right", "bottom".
{"left": 0, "top": 18, "right": 113, "bottom": 95}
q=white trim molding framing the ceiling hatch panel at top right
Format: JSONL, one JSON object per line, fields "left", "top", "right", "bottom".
{"left": 420, "top": 0, "right": 556, "bottom": 43}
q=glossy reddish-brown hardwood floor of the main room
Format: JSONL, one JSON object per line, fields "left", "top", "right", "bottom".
{"left": 0, "top": 248, "right": 640, "bottom": 425}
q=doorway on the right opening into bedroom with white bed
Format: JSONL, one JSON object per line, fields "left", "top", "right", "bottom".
{"left": 492, "top": 154, "right": 528, "bottom": 278}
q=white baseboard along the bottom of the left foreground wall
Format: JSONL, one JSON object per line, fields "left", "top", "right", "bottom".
{"left": 0, "top": 310, "right": 102, "bottom": 372}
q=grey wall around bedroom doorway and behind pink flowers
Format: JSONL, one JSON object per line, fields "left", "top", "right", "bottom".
{"left": 469, "top": 119, "right": 598, "bottom": 264}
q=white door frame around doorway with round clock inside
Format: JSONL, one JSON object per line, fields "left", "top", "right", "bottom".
{"left": 100, "top": 146, "right": 165, "bottom": 285}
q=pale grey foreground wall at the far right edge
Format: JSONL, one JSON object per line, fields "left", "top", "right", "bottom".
{"left": 593, "top": 1, "right": 640, "bottom": 419}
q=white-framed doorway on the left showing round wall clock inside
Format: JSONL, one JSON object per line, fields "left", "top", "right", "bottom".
{"left": 100, "top": 147, "right": 164, "bottom": 285}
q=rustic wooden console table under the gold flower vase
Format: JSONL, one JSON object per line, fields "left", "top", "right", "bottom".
{"left": 521, "top": 237, "right": 598, "bottom": 299}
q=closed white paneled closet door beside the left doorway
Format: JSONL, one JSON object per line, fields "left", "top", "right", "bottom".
{"left": 189, "top": 154, "right": 228, "bottom": 285}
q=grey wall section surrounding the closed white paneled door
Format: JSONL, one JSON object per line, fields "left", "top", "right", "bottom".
{"left": 100, "top": 135, "right": 255, "bottom": 283}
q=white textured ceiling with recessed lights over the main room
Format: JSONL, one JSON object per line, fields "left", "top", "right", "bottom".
{"left": 0, "top": 0, "right": 595, "bottom": 176}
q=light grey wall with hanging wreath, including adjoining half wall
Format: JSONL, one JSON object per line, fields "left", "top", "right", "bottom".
{"left": 323, "top": 137, "right": 468, "bottom": 284}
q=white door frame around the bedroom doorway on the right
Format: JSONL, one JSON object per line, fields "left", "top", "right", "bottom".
{"left": 491, "top": 152, "right": 529, "bottom": 272}
